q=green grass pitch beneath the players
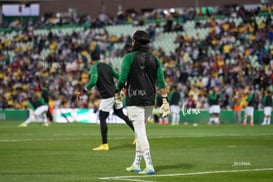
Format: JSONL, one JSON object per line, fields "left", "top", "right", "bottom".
{"left": 0, "top": 121, "right": 273, "bottom": 182}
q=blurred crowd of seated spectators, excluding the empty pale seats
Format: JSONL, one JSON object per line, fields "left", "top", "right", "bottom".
{"left": 0, "top": 4, "right": 273, "bottom": 114}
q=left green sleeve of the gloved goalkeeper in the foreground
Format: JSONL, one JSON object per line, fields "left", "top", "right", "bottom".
{"left": 117, "top": 52, "right": 135, "bottom": 90}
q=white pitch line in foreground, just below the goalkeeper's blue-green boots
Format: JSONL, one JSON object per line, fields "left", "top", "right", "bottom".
{"left": 98, "top": 168, "right": 273, "bottom": 182}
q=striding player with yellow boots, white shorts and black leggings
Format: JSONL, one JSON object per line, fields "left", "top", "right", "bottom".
{"left": 78, "top": 51, "right": 134, "bottom": 150}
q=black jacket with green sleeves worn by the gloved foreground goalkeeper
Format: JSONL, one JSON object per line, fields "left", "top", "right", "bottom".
{"left": 118, "top": 51, "right": 166, "bottom": 106}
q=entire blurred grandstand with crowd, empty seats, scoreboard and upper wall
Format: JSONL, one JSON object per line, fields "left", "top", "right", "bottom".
{"left": 0, "top": 0, "right": 273, "bottom": 122}
